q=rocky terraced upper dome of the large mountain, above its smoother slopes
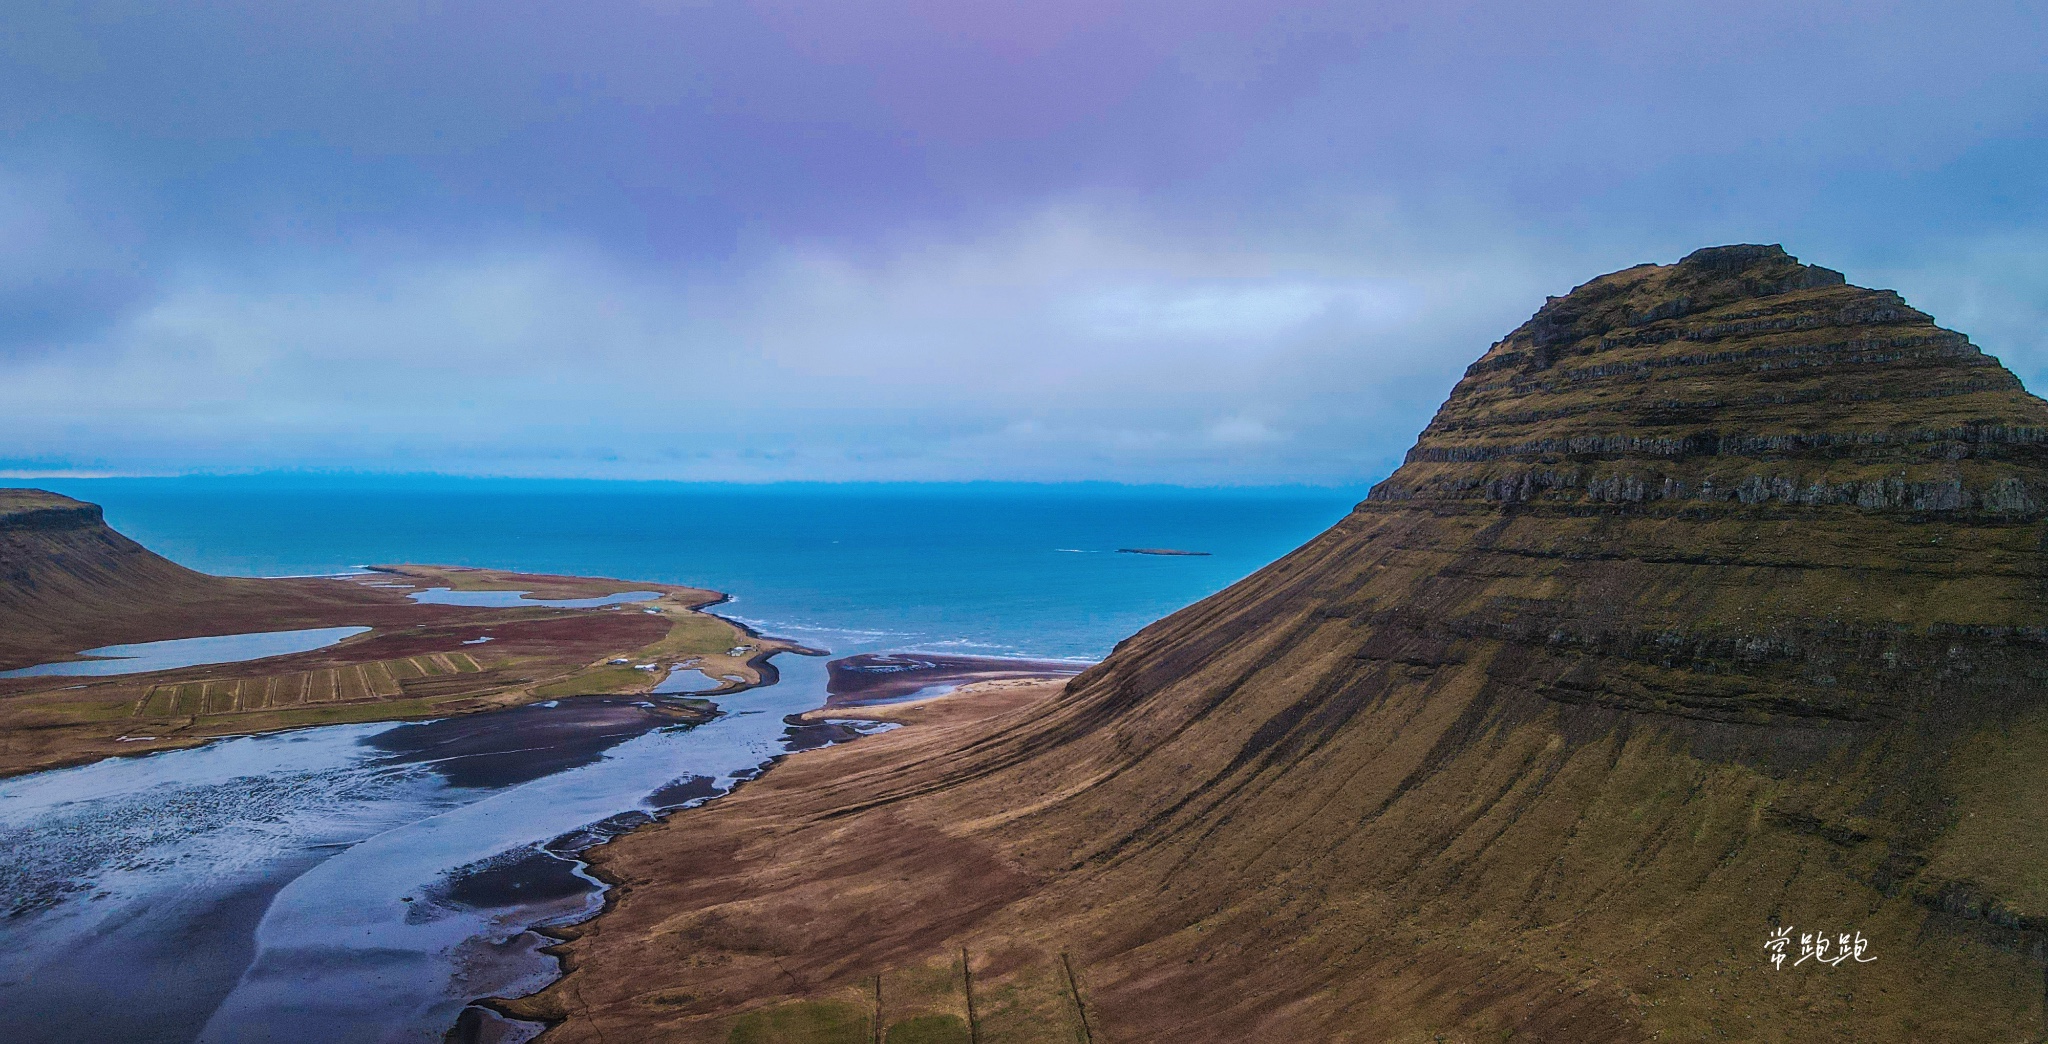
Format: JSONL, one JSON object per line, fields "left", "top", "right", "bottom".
{"left": 1374, "top": 246, "right": 2048, "bottom": 516}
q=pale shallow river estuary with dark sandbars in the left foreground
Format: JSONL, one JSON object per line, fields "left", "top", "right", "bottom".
{"left": 0, "top": 626, "right": 888, "bottom": 1042}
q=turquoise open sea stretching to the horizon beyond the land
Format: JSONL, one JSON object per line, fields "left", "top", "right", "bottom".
{"left": 18, "top": 477, "right": 1364, "bottom": 659}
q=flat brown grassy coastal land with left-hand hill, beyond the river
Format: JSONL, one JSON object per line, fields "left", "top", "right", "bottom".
{"left": 0, "top": 489, "right": 813, "bottom": 778}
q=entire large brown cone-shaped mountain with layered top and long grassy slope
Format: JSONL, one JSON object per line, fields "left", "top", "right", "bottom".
{"left": 522, "top": 246, "right": 2048, "bottom": 1042}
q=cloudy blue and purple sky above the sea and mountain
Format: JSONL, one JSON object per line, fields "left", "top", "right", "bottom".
{"left": 0, "top": 0, "right": 2048, "bottom": 485}
